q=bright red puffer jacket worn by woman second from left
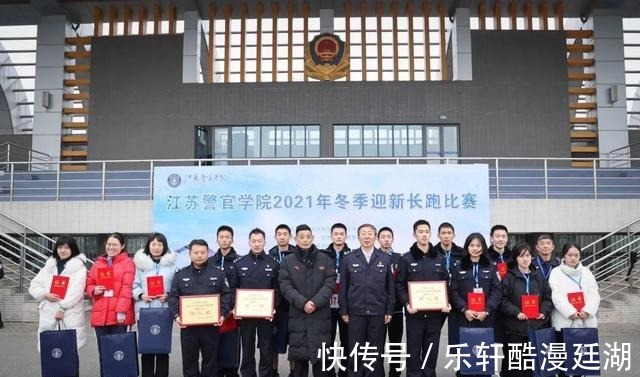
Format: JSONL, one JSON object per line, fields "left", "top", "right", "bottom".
{"left": 85, "top": 252, "right": 136, "bottom": 327}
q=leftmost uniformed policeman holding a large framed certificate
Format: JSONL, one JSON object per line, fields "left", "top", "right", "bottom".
{"left": 169, "top": 239, "right": 232, "bottom": 377}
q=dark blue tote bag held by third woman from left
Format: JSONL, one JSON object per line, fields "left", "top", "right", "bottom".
{"left": 138, "top": 308, "right": 173, "bottom": 353}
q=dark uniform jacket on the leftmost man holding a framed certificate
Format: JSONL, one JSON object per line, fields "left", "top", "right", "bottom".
{"left": 169, "top": 262, "right": 233, "bottom": 317}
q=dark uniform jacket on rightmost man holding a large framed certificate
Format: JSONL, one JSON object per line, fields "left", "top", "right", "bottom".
{"left": 396, "top": 242, "right": 449, "bottom": 317}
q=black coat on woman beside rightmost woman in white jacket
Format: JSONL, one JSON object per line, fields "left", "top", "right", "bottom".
{"left": 502, "top": 264, "right": 553, "bottom": 336}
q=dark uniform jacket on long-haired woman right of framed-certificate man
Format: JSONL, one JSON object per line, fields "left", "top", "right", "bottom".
{"left": 449, "top": 254, "right": 502, "bottom": 327}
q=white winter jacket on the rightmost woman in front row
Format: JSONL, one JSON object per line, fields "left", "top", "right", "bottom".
{"left": 549, "top": 261, "right": 600, "bottom": 331}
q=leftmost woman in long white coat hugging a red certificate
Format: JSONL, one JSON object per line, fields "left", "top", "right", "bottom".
{"left": 29, "top": 236, "right": 87, "bottom": 349}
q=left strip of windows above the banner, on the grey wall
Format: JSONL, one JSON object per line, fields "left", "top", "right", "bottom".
{"left": 195, "top": 124, "right": 320, "bottom": 159}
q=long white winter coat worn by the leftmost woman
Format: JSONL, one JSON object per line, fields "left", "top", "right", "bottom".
{"left": 29, "top": 254, "right": 87, "bottom": 350}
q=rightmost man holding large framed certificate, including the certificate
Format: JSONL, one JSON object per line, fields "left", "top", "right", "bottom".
{"left": 396, "top": 220, "right": 451, "bottom": 377}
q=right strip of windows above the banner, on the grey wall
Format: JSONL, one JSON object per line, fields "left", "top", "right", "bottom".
{"left": 333, "top": 124, "right": 459, "bottom": 157}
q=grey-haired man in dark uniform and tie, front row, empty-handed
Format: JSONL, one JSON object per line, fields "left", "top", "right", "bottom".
{"left": 338, "top": 224, "right": 395, "bottom": 377}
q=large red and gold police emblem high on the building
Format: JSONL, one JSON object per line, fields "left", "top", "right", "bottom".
{"left": 304, "top": 33, "right": 349, "bottom": 81}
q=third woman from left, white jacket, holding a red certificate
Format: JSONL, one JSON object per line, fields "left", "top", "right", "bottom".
{"left": 133, "top": 233, "right": 176, "bottom": 377}
